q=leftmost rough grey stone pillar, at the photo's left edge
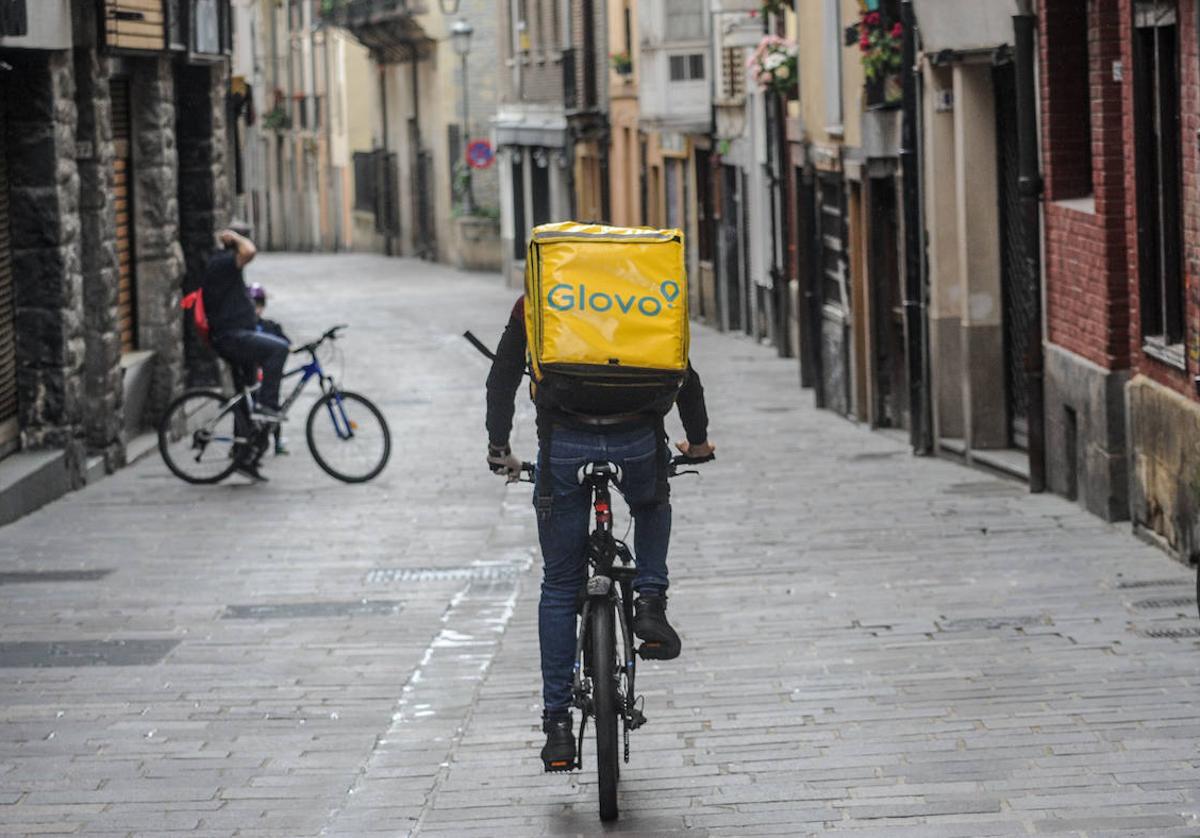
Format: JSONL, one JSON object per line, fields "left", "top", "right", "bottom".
{"left": 4, "top": 50, "right": 84, "bottom": 463}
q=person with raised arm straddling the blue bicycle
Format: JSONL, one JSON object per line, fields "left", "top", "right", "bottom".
{"left": 202, "top": 228, "right": 289, "bottom": 480}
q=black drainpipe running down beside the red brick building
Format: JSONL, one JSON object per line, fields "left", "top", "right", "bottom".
{"left": 1013, "top": 0, "right": 1046, "bottom": 492}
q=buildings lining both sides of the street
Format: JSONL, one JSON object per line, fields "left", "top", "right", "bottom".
{"left": 7, "top": 0, "right": 1200, "bottom": 571}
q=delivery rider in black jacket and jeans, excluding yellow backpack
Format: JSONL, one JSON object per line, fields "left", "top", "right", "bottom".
{"left": 487, "top": 298, "right": 714, "bottom": 771}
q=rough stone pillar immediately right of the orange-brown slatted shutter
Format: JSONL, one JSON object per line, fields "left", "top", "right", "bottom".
{"left": 131, "top": 58, "right": 184, "bottom": 427}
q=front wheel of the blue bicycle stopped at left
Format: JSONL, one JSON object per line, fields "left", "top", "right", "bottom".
{"left": 305, "top": 390, "right": 391, "bottom": 483}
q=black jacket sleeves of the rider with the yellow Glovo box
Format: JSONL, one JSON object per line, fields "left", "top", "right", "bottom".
{"left": 487, "top": 298, "right": 708, "bottom": 447}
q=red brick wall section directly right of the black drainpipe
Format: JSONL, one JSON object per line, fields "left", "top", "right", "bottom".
{"left": 1040, "top": 0, "right": 1132, "bottom": 370}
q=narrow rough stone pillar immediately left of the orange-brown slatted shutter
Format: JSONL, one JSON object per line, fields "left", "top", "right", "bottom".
{"left": 74, "top": 48, "right": 125, "bottom": 469}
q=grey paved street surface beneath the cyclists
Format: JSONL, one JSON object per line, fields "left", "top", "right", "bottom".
{"left": 0, "top": 255, "right": 1200, "bottom": 838}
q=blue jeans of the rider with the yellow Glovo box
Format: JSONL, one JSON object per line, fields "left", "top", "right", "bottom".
{"left": 538, "top": 427, "right": 671, "bottom": 714}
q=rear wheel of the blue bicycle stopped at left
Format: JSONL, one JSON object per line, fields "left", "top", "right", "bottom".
{"left": 158, "top": 390, "right": 236, "bottom": 484}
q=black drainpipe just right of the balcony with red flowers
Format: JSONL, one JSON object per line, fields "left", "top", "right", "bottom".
{"left": 900, "top": 0, "right": 931, "bottom": 454}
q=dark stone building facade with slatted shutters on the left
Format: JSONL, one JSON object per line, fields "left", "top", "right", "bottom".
{"left": 0, "top": 0, "right": 230, "bottom": 518}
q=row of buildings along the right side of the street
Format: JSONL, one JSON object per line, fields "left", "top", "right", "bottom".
{"left": 480, "top": 0, "right": 1200, "bottom": 562}
